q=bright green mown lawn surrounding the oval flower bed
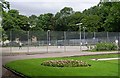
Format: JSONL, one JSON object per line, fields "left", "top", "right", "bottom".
{"left": 5, "top": 54, "right": 120, "bottom": 78}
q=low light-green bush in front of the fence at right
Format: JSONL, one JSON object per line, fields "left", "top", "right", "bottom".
{"left": 92, "top": 42, "right": 117, "bottom": 51}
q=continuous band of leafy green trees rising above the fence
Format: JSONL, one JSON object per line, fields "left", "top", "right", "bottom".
{"left": 1, "top": 2, "right": 120, "bottom": 32}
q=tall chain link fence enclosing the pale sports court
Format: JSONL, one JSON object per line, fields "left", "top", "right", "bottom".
{"left": 1, "top": 30, "right": 120, "bottom": 53}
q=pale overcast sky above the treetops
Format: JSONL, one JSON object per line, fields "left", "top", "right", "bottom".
{"left": 6, "top": 0, "right": 100, "bottom": 16}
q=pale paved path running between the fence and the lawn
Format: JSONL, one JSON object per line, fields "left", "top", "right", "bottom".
{"left": 3, "top": 51, "right": 120, "bottom": 65}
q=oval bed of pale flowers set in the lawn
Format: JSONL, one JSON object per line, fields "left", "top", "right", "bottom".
{"left": 41, "top": 60, "right": 91, "bottom": 67}
